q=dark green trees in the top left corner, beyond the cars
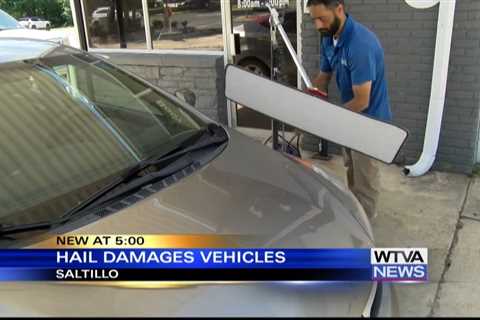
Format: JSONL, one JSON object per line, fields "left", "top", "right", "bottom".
{"left": 0, "top": 0, "right": 73, "bottom": 27}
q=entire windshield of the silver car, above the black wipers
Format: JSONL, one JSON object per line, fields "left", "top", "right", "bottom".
{"left": 0, "top": 47, "right": 207, "bottom": 225}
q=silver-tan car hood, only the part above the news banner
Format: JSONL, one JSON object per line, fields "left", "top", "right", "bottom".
{"left": 55, "top": 131, "right": 372, "bottom": 248}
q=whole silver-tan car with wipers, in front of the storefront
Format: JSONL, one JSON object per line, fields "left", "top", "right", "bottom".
{"left": 0, "top": 39, "right": 396, "bottom": 316}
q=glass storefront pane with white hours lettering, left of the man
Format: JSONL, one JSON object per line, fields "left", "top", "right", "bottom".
{"left": 231, "top": 0, "right": 297, "bottom": 129}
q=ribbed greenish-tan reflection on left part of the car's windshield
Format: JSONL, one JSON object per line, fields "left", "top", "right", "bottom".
{"left": 0, "top": 63, "right": 134, "bottom": 226}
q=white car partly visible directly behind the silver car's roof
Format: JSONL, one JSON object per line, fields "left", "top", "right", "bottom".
{"left": 0, "top": 9, "right": 69, "bottom": 45}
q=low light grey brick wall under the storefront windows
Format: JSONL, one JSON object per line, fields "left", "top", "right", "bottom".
{"left": 95, "top": 51, "right": 227, "bottom": 123}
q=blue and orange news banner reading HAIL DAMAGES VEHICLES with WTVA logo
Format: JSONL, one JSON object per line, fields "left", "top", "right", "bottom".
{"left": 0, "top": 235, "right": 428, "bottom": 282}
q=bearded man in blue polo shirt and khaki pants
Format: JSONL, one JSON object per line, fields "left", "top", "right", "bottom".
{"left": 307, "top": 0, "right": 392, "bottom": 218}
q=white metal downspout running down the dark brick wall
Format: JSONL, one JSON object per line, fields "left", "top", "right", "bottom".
{"left": 403, "top": 0, "right": 456, "bottom": 177}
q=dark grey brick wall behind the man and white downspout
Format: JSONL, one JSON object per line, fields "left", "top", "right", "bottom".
{"left": 302, "top": 0, "right": 480, "bottom": 173}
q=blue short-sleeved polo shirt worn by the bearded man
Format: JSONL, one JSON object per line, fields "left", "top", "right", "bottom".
{"left": 320, "top": 15, "right": 392, "bottom": 121}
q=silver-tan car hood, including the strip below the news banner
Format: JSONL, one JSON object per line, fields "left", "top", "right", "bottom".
{"left": 0, "top": 131, "right": 372, "bottom": 316}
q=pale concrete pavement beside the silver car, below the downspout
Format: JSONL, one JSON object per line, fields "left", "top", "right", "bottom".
{"left": 240, "top": 128, "right": 480, "bottom": 316}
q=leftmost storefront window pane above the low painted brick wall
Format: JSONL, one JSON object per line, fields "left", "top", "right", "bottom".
{"left": 83, "top": 0, "right": 147, "bottom": 49}
